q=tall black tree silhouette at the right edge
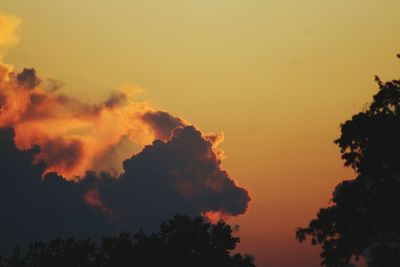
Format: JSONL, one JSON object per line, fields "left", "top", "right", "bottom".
{"left": 296, "top": 73, "right": 400, "bottom": 267}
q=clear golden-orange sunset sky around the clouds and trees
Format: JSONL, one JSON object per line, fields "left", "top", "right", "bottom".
{"left": 0, "top": 0, "right": 400, "bottom": 267}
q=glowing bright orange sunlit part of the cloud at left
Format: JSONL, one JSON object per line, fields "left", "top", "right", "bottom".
{"left": 0, "top": 64, "right": 159, "bottom": 179}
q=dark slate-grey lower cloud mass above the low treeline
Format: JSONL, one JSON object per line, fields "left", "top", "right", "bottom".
{"left": 0, "top": 126, "right": 250, "bottom": 254}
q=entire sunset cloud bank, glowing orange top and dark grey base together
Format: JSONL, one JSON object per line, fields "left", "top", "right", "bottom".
{"left": 0, "top": 15, "right": 250, "bottom": 252}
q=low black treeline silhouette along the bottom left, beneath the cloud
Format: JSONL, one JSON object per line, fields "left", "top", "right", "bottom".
{"left": 0, "top": 215, "right": 255, "bottom": 267}
